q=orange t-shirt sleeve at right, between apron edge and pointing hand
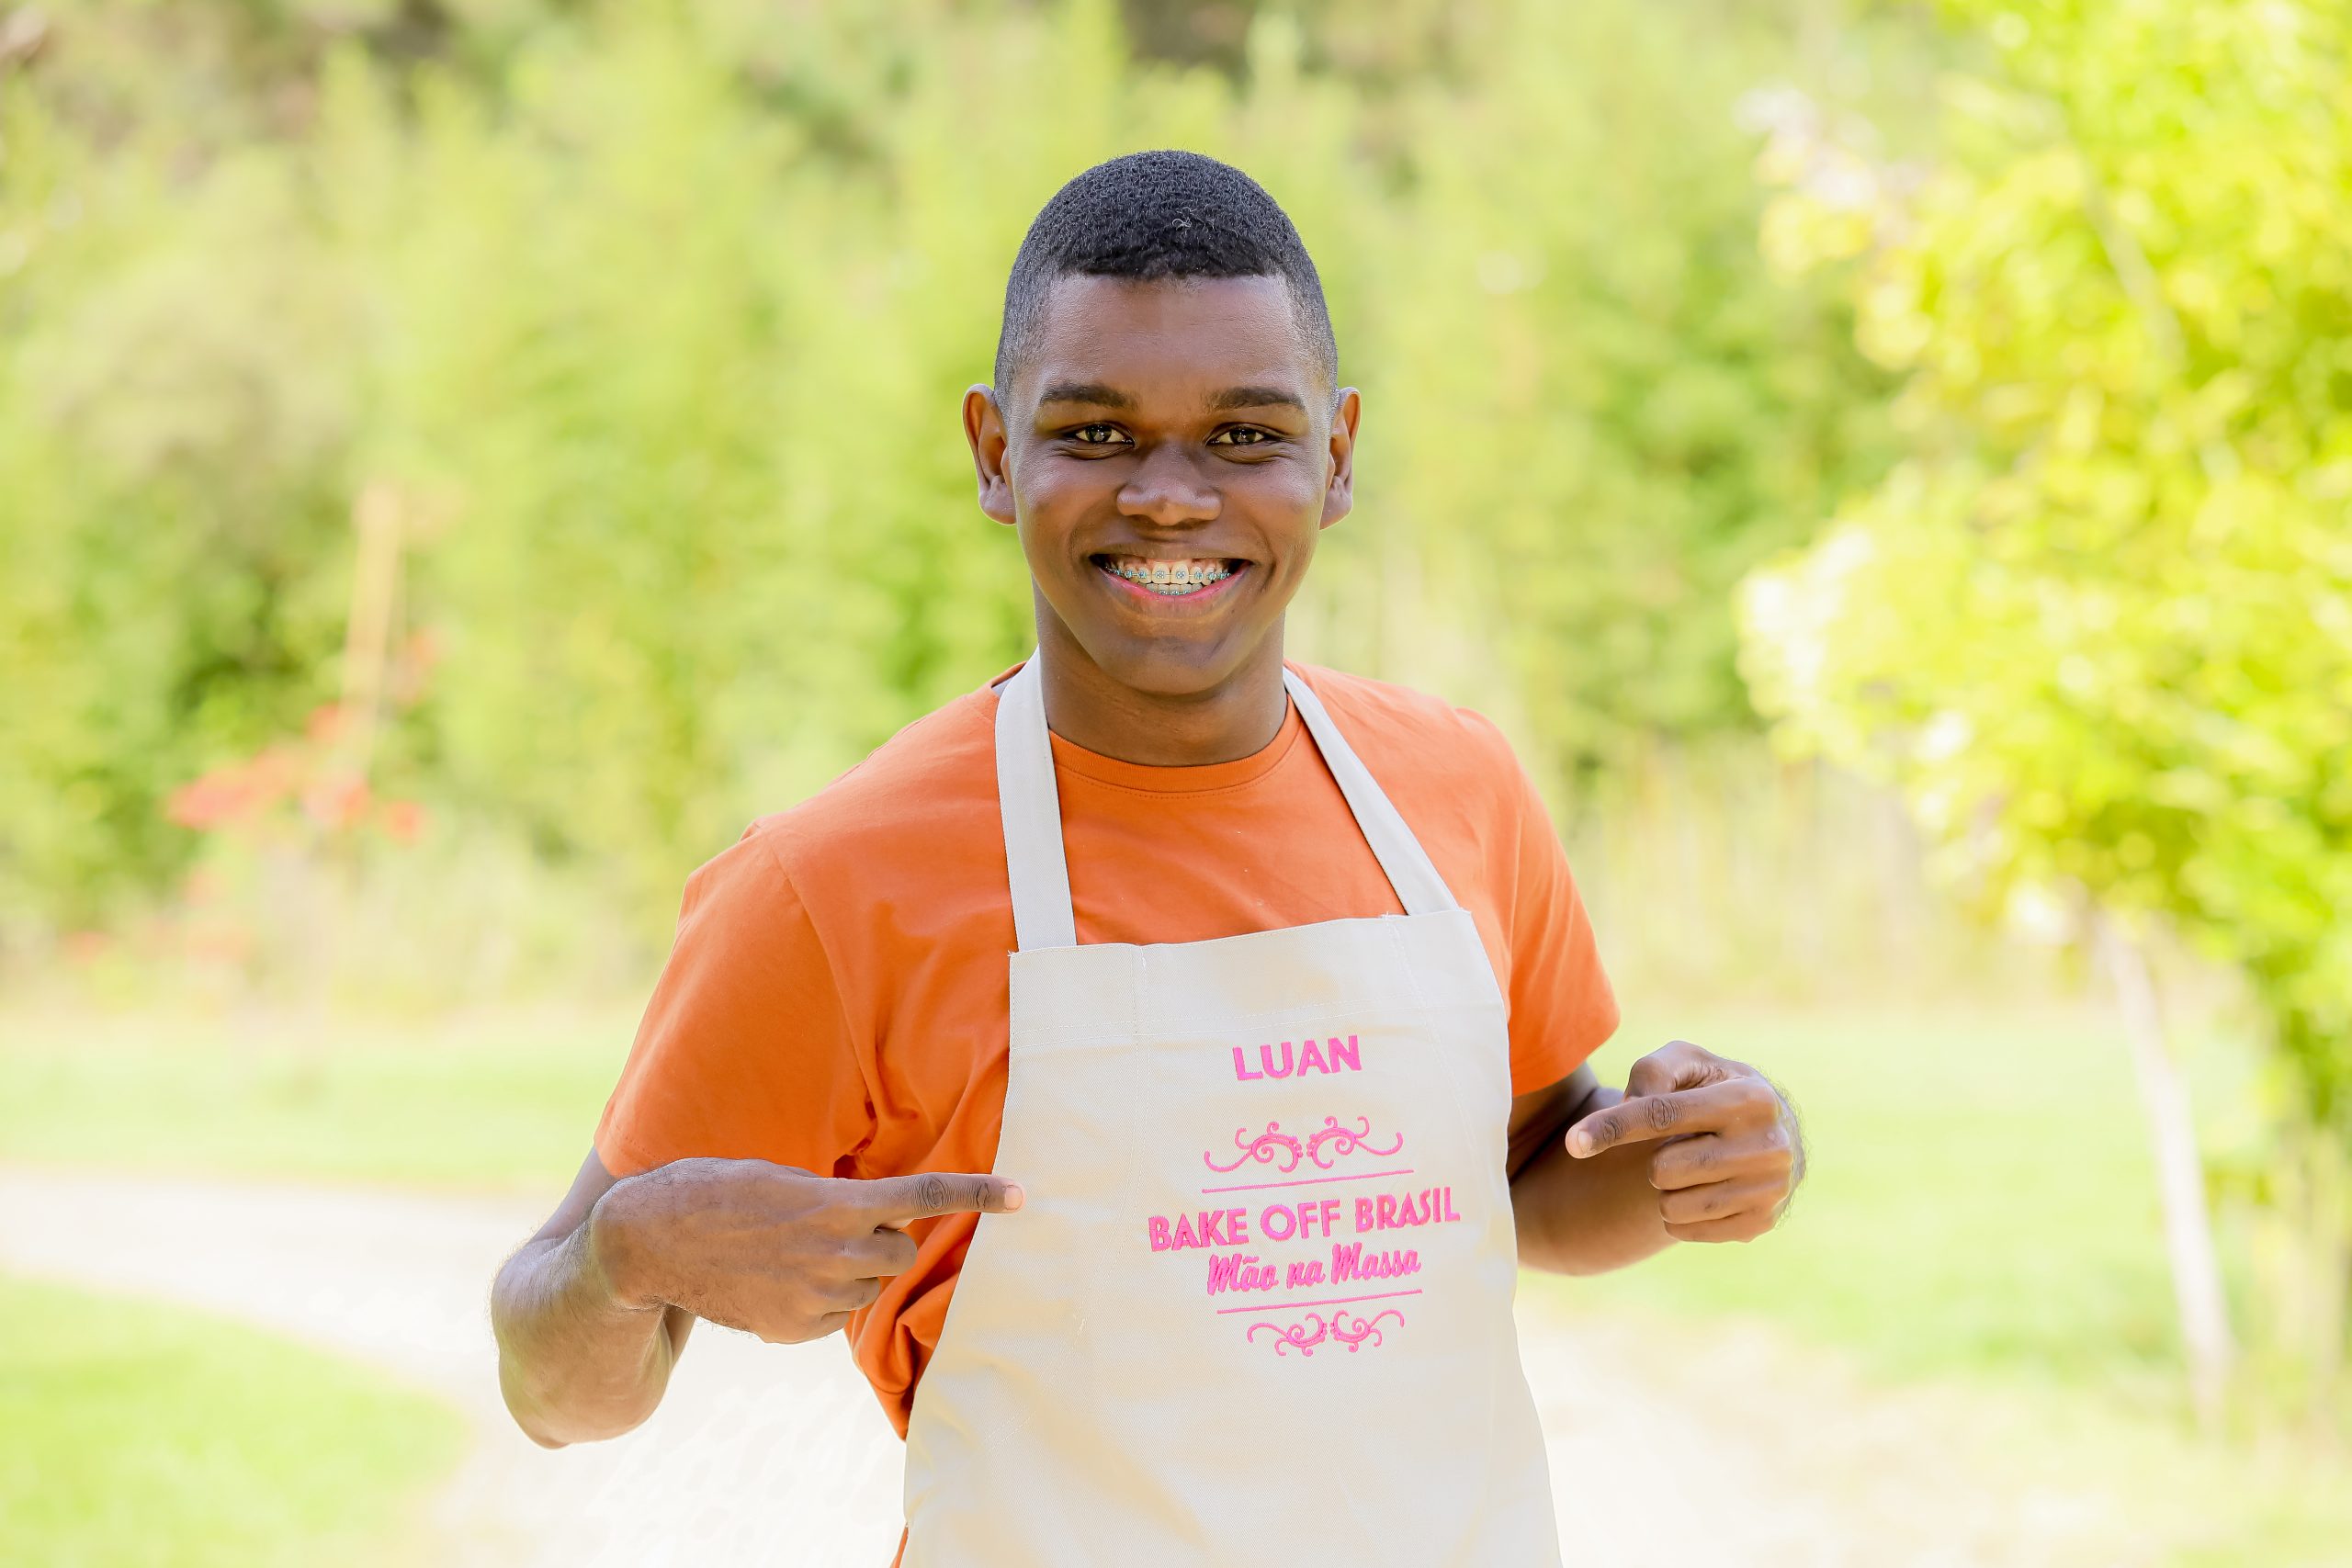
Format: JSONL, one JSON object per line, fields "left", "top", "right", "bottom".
{"left": 1479, "top": 717, "right": 1618, "bottom": 1096}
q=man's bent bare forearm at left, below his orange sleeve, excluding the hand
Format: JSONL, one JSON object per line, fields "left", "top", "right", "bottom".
{"left": 489, "top": 1189, "right": 694, "bottom": 1448}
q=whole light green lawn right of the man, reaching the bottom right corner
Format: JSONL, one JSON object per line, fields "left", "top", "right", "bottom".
{"left": 1526, "top": 1009, "right": 2352, "bottom": 1568}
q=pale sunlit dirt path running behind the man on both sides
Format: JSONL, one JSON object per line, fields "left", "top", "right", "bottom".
{"left": 0, "top": 1168, "right": 2162, "bottom": 1568}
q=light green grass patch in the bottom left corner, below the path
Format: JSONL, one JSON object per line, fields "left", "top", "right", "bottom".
{"left": 0, "top": 1277, "right": 463, "bottom": 1568}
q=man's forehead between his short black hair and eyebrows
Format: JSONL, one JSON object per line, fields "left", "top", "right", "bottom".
{"left": 1021, "top": 277, "right": 1315, "bottom": 404}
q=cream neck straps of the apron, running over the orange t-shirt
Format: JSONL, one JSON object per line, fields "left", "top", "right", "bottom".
{"left": 997, "top": 653, "right": 1461, "bottom": 952}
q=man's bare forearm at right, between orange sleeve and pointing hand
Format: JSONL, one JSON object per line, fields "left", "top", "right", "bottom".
{"left": 1510, "top": 1065, "right": 1672, "bottom": 1274}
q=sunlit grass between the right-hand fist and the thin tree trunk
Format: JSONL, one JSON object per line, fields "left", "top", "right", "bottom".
{"left": 1562, "top": 1010, "right": 2176, "bottom": 1387}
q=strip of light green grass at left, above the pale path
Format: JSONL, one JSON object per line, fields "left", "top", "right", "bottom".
{"left": 0, "top": 1013, "right": 630, "bottom": 1192}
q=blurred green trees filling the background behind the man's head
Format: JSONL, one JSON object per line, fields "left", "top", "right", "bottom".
{"left": 0, "top": 0, "right": 1886, "bottom": 931}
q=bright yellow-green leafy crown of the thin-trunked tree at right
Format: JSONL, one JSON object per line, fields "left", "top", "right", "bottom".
{"left": 1746, "top": 0, "right": 2352, "bottom": 1392}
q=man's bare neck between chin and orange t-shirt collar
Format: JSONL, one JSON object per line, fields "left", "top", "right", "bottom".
{"left": 1040, "top": 623, "right": 1289, "bottom": 769}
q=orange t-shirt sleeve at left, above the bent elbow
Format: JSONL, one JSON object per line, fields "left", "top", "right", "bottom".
{"left": 595, "top": 825, "right": 873, "bottom": 1176}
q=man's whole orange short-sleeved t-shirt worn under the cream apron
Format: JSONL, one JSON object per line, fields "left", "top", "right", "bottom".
{"left": 595, "top": 663, "right": 1618, "bottom": 1437}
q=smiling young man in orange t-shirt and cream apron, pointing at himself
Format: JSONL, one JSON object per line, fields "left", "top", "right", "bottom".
{"left": 494, "top": 152, "right": 1802, "bottom": 1568}
